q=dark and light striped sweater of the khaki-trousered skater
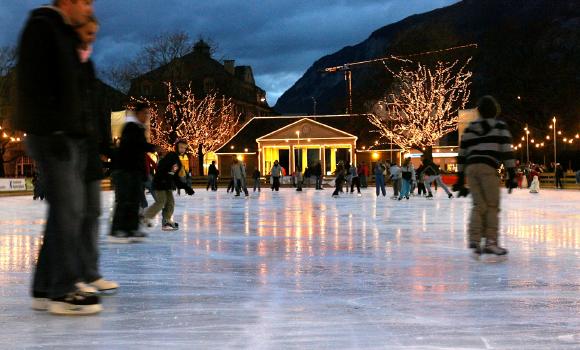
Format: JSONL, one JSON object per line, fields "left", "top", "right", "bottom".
{"left": 457, "top": 117, "right": 516, "bottom": 172}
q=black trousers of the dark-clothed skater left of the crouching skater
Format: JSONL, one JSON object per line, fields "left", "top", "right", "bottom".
{"left": 111, "top": 170, "right": 144, "bottom": 232}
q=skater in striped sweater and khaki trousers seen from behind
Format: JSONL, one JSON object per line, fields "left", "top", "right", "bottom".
{"left": 455, "top": 96, "right": 516, "bottom": 255}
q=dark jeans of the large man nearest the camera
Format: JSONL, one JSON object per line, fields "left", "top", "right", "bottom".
{"left": 26, "top": 135, "right": 89, "bottom": 298}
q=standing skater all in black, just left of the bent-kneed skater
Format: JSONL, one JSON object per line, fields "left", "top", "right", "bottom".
{"left": 109, "top": 103, "right": 155, "bottom": 243}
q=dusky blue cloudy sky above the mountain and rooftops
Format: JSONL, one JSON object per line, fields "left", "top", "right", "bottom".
{"left": 0, "top": 0, "right": 457, "bottom": 105}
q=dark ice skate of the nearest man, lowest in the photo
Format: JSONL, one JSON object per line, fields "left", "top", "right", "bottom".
{"left": 48, "top": 291, "right": 103, "bottom": 316}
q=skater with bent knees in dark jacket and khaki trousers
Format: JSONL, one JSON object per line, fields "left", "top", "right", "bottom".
{"left": 143, "top": 141, "right": 195, "bottom": 231}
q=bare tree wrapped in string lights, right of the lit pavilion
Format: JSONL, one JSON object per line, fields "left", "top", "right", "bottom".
{"left": 369, "top": 59, "right": 472, "bottom": 153}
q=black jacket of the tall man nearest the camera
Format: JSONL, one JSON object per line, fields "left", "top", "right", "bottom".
{"left": 12, "top": 6, "right": 90, "bottom": 137}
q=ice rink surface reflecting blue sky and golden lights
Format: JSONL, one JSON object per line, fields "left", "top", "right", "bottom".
{"left": 0, "top": 188, "right": 580, "bottom": 350}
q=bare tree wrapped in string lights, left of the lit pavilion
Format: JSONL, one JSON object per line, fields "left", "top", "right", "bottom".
{"left": 134, "top": 83, "right": 239, "bottom": 172}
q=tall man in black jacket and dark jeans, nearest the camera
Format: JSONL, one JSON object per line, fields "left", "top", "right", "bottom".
{"left": 12, "top": 0, "right": 102, "bottom": 315}
